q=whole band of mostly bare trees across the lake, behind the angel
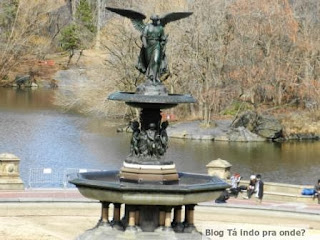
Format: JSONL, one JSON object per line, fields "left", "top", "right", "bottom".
{"left": 0, "top": 0, "right": 320, "bottom": 122}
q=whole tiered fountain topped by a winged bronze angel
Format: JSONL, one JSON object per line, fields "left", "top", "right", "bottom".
{"left": 69, "top": 8, "right": 229, "bottom": 240}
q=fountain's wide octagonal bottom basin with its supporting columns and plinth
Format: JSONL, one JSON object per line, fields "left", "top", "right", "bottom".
{"left": 69, "top": 171, "right": 229, "bottom": 240}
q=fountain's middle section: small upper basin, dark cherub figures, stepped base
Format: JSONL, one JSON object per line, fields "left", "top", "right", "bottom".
{"left": 108, "top": 86, "right": 195, "bottom": 184}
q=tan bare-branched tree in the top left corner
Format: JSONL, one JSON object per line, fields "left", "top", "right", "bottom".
{"left": 0, "top": 0, "right": 65, "bottom": 79}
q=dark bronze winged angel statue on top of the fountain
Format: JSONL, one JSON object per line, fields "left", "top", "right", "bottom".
{"left": 107, "top": 7, "right": 192, "bottom": 85}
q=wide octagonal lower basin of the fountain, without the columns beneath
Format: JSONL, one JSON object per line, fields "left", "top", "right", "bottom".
{"left": 69, "top": 171, "right": 230, "bottom": 206}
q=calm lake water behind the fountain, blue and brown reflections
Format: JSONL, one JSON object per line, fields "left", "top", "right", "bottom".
{"left": 0, "top": 88, "right": 320, "bottom": 184}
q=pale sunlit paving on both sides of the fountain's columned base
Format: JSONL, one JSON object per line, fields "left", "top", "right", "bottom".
{"left": 0, "top": 189, "right": 320, "bottom": 240}
